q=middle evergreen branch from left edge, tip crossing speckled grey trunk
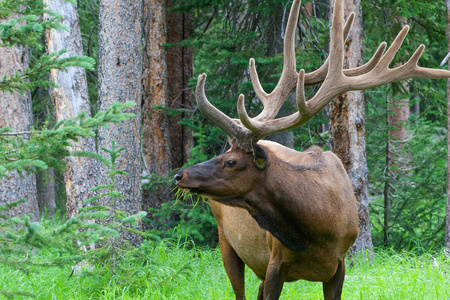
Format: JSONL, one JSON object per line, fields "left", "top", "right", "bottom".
{"left": 0, "top": 102, "right": 136, "bottom": 178}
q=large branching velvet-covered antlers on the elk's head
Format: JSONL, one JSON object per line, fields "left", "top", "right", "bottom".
{"left": 196, "top": 0, "right": 450, "bottom": 152}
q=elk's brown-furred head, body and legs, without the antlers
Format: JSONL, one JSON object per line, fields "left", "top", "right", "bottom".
{"left": 176, "top": 141, "right": 358, "bottom": 300}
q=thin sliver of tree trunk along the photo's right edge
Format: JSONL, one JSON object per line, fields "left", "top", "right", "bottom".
{"left": 445, "top": 0, "right": 450, "bottom": 255}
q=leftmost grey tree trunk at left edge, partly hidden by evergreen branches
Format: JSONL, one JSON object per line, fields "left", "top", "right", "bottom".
{"left": 0, "top": 15, "right": 39, "bottom": 221}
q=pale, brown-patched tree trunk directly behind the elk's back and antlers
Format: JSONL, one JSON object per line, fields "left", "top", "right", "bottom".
{"left": 330, "top": 0, "right": 373, "bottom": 253}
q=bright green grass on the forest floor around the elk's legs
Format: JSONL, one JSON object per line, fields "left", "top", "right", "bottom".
{"left": 0, "top": 242, "right": 450, "bottom": 300}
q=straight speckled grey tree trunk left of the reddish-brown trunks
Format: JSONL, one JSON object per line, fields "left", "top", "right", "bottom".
{"left": 98, "top": 0, "right": 142, "bottom": 245}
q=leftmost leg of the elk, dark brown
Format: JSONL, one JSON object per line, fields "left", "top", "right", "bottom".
{"left": 219, "top": 227, "right": 245, "bottom": 300}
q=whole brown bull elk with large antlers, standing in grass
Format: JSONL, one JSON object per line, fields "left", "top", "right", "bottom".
{"left": 175, "top": 0, "right": 450, "bottom": 299}
